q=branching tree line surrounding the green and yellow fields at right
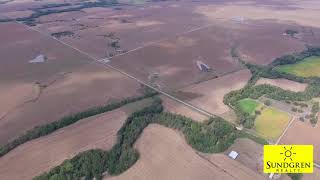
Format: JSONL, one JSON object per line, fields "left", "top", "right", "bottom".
{"left": 224, "top": 46, "right": 320, "bottom": 128}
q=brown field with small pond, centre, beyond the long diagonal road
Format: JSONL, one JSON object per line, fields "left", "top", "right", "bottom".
{"left": 110, "top": 27, "right": 242, "bottom": 90}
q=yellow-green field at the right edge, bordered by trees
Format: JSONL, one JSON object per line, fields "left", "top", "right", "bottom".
{"left": 275, "top": 56, "right": 320, "bottom": 77}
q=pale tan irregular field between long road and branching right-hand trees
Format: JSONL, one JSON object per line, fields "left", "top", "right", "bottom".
{"left": 181, "top": 70, "right": 251, "bottom": 119}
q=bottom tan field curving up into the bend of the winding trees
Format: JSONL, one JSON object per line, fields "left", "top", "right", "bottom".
{"left": 105, "top": 125, "right": 261, "bottom": 180}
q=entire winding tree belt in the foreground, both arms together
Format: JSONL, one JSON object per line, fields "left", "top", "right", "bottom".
{"left": 34, "top": 97, "right": 266, "bottom": 180}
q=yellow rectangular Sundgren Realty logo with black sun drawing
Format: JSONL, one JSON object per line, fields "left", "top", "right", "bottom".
{"left": 263, "top": 145, "right": 313, "bottom": 173}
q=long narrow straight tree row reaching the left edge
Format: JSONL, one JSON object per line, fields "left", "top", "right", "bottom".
{"left": 0, "top": 91, "right": 157, "bottom": 157}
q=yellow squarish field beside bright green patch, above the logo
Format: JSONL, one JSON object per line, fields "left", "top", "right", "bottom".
{"left": 254, "top": 107, "right": 290, "bottom": 141}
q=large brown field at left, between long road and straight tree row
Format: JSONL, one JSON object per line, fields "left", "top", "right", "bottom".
{"left": 0, "top": 23, "right": 140, "bottom": 144}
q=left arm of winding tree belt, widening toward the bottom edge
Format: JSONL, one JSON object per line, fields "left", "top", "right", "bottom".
{"left": 34, "top": 98, "right": 163, "bottom": 180}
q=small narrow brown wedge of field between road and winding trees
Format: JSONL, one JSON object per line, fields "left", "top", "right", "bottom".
{"left": 161, "top": 96, "right": 208, "bottom": 122}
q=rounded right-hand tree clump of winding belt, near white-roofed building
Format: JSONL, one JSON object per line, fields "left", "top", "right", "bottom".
{"left": 153, "top": 113, "right": 237, "bottom": 153}
